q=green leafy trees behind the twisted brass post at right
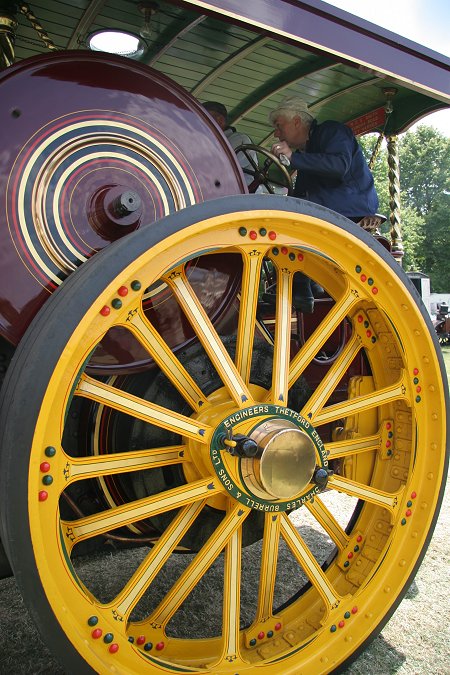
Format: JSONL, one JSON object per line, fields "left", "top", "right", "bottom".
{"left": 359, "top": 125, "right": 450, "bottom": 292}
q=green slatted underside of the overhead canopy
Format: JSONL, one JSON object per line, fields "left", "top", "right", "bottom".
{"left": 5, "top": 0, "right": 444, "bottom": 145}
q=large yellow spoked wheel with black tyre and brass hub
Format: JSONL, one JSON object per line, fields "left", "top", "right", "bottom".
{"left": 1, "top": 195, "right": 446, "bottom": 675}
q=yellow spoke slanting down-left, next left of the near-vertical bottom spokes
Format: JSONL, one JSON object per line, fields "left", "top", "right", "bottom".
{"left": 145, "top": 504, "right": 250, "bottom": 628}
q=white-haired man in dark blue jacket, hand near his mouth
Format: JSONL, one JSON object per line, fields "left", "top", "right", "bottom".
{"left": 269, "top": 97, "right": 378, "bottom": 215}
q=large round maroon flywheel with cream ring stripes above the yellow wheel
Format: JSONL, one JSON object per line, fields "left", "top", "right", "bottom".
{"left": 0, "top": 52, "right": 247, "bottom": 344}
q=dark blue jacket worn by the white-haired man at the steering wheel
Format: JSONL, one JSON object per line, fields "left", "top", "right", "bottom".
{"left": 291, "top": 120, "right": 378, "bottom": 219}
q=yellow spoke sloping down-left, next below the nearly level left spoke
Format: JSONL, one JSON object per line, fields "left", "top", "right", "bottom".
{"left": 61, "top": 476, "right": 222, "bottom": 552}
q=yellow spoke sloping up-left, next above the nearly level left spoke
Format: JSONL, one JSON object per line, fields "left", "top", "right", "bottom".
{"left": 75, "top": 375, "right": 212, "bottom": 443}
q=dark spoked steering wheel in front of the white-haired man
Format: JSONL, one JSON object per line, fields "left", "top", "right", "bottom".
{"left": 235, "top": 143, "right": 293, "bottom": 196}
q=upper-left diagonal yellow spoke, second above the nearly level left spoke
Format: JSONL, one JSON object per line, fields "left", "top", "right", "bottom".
{"left": 126, "top": 311, "right": 206, "bottom": 411}
